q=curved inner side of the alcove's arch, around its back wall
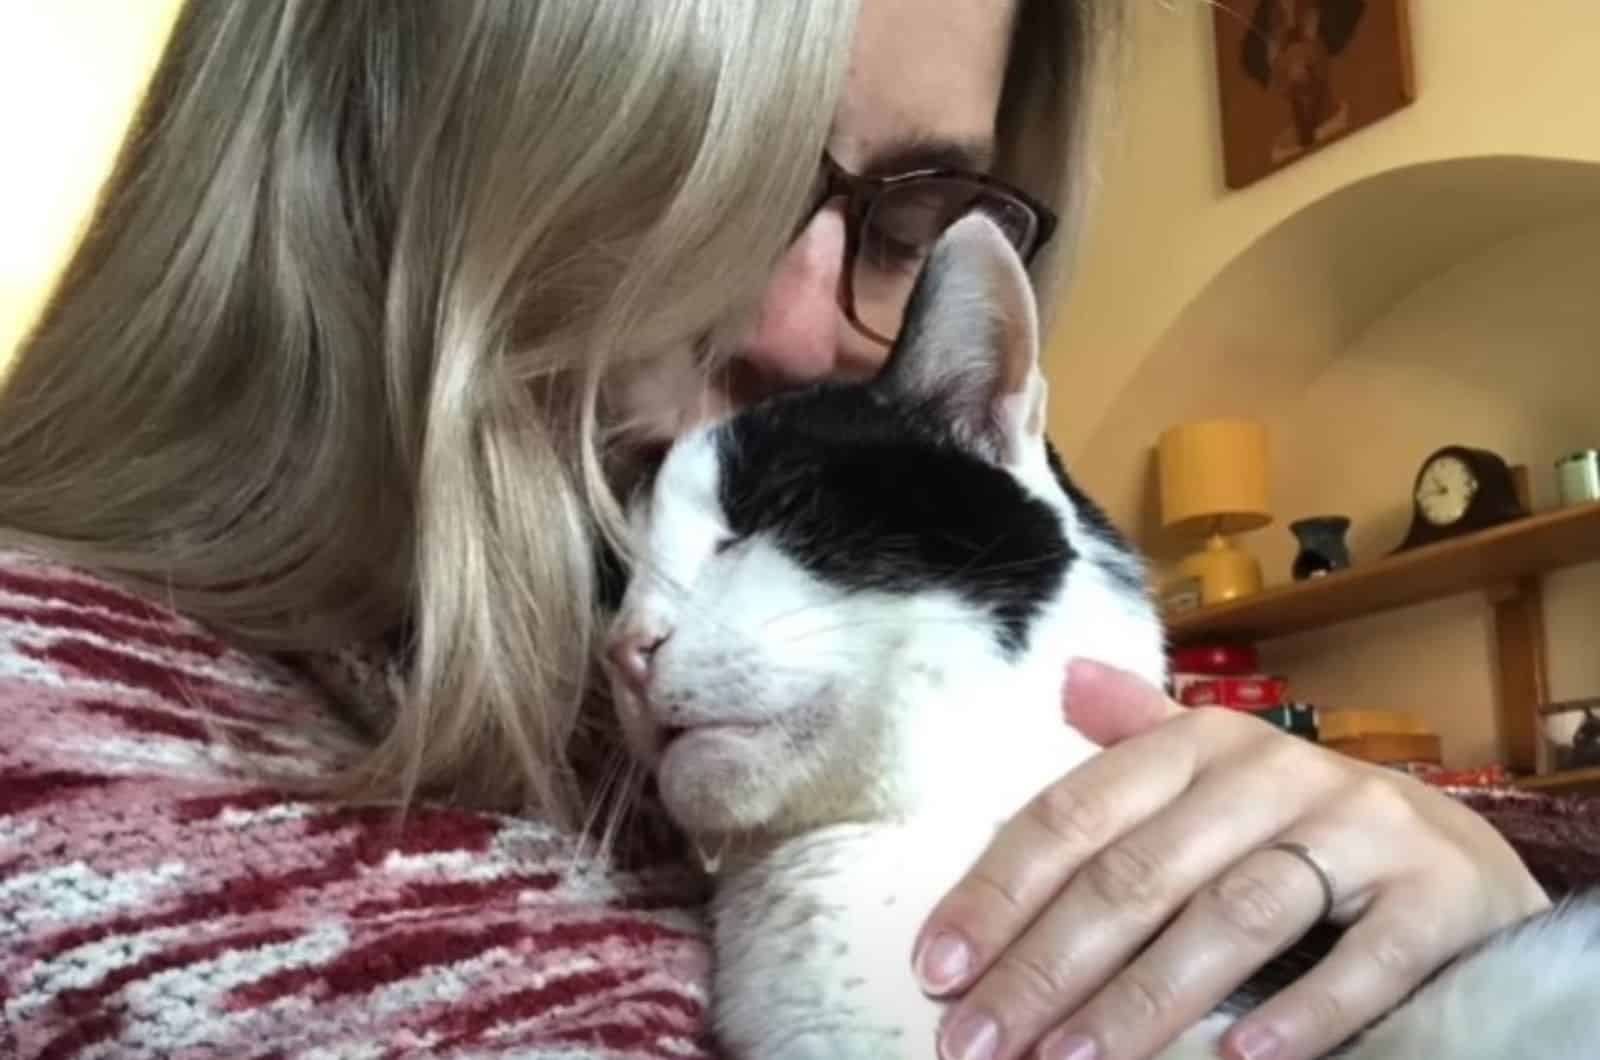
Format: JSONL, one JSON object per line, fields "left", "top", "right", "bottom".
{"left": 1074, "top": 155, "right": 1600, "bottom": 552}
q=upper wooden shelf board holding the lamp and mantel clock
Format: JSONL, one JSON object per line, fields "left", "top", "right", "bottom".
{"left": 1166, "top": 504, "right": 1600, "bottom": 644}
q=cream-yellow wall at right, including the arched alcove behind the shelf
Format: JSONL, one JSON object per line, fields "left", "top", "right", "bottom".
{"left": 1050, "top": 0, "right": 1600, "bottom": 764}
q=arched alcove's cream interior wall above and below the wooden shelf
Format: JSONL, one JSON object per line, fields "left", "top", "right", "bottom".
{"left": 1072, "top": 157, "right": 1600, "bottom": 765}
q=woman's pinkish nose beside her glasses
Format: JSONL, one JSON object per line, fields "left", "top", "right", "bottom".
{"left": 741, "top": 207, "right": 845, "bottom": 387}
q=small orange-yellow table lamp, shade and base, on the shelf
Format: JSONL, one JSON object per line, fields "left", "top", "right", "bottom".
{"left": 1158, "top": 420, "right": 1272, "bottom": 604}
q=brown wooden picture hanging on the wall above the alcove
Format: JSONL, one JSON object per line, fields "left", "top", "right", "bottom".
{"left": 1213, "top": 0, "right": 1416, "bottom": 189}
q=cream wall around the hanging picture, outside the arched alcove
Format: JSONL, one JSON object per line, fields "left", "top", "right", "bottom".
{"left": 1050, "top": 0, "right": 1600, "bottom": 458}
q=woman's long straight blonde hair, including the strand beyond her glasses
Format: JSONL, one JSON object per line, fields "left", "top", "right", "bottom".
{"left": 0, "top": 0, "right": 1120, "bottom": 825}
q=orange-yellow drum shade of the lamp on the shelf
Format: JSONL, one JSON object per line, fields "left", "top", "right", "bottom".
{"left": 1157, "top": 420, "right": 1272, "bottom": 535}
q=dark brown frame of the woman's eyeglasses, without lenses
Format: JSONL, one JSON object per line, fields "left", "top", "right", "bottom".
{"left": 795, "top": 152, "right": 1059, "bottom": 346}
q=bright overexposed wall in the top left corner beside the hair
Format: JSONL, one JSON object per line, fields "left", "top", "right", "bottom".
{"left": 0, "top": 0, "right": 179, "bottom": 370}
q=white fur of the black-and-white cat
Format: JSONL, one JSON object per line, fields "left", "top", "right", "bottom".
{"left": 616, "top": 221, "right": 1600, "bottom": 1060}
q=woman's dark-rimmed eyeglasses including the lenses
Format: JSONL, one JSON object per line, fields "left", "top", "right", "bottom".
{"left": 802, "top": 154, "right": 1056, "bottom": 346}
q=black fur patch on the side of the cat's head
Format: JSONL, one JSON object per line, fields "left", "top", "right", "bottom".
{"left": 717, "top": 384, "right": 1075, "bottom": 655}
